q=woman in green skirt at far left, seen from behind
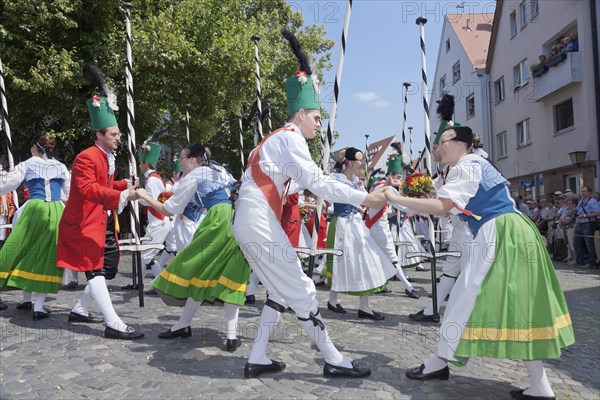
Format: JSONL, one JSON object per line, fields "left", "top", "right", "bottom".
{"left": 0, "top": 135, "right": 71, "bottom": 321}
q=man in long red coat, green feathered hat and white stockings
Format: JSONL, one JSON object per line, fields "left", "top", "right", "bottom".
{"left": 57, "top": 89, "right": 144, "bottom": 340}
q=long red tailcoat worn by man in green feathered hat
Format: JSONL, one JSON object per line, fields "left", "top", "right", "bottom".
{"left": 57, "top": 146, "right": 127, "bottom": 271}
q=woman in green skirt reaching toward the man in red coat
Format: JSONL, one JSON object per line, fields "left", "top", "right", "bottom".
{"left": 138, "top": 144, "right": 250, "bottom": 352}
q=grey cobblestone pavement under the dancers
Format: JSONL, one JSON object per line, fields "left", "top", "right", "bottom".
{"left": 0, "top": 257, "right": 600, "bottom": 399}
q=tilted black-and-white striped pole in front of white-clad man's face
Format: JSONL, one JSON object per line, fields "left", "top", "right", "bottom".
{"left": 308, "top": 0, "right": 352, "bottom": 279}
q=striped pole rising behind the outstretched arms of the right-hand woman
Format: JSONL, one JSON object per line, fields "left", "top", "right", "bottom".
{"left": 416, "top": 17, "right": 439, "bottom": 318}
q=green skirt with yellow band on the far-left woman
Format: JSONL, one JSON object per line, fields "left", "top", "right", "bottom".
{"left": 0, "top": 199, "right": 64, "bottom": 293}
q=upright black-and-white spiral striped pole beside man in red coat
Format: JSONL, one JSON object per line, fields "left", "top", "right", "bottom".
{"left": 121, "top": 2, "right": 144, "bottom": 307}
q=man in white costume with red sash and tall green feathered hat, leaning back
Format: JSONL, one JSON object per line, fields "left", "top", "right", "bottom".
{"left": 233, "top": 31, "right": 385, "bottom": 378}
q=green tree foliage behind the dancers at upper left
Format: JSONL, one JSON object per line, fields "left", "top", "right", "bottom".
{"left": 0, "top": 0, "right": 333, "bottom": 175}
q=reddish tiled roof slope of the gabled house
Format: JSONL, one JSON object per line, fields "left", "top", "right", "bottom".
{"left": 445, "top": 13, "right": 494, "bottom": 69}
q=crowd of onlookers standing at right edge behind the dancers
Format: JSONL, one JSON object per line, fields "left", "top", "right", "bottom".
{"left": 514, "top": 186, "right": 600, "bottom": 267}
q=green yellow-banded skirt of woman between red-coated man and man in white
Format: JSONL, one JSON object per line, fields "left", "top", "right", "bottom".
{"left": 152, "top": 203, "right": 250, "bottom": 306}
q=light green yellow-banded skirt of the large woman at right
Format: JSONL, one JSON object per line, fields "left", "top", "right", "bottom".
{"left": 454, "top": 213, "right": 575, "bottom": 360}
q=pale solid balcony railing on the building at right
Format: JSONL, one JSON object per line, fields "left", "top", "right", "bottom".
{"left": 533, "top": 52, "right": 582, "bottom": 101}
